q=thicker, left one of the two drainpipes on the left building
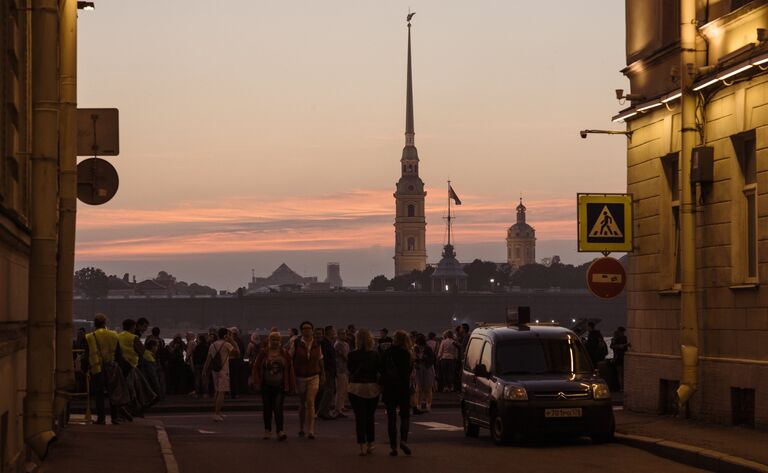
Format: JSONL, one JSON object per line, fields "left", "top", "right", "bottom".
{"left": 24, "top": 0, "right": 59, "bottom": 458}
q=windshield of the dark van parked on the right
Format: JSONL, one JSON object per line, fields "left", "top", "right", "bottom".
{"left": 496, "top": 339, "right": 592, "bottom": 375}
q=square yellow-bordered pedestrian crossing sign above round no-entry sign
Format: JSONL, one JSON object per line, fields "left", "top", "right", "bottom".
{"left": 577, "top": 194, "right": 632, "bottom": 253}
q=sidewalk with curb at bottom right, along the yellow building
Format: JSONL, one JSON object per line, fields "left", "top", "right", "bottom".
{"left": 614, "top": 410, "right": 768, "bottom": 473}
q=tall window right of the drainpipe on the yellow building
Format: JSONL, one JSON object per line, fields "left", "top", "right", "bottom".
{"left": 731, "top": 130, "right": 758, "bottom": 283}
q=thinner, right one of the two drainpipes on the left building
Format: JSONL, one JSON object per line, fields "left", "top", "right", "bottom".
{"left": 53, "top": 0, "right": 77, "bottom": 420}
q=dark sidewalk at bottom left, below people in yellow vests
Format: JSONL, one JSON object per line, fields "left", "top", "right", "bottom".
{"left": 35, "top": 419, "right": 166, "bottom": 473}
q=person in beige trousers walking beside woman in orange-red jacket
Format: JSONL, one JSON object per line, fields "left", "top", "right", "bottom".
{"left": 290, "top": 322, "right": 325, "bottom": 440}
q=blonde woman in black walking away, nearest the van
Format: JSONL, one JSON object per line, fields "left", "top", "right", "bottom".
{"left": 379, "top": 330, "right": 413, "bottom": 457}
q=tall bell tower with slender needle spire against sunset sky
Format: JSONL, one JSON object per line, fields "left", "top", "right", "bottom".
{"left": 394, "top": 13, "right": 427, "bottom": 276}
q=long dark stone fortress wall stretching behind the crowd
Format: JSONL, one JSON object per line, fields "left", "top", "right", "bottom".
{"left": 75, "top": 291, "right": 626, "bottom": 335}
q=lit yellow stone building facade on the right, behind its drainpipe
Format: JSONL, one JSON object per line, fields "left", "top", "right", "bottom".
{"left": 614, "top": 0, "right": 768, "bottom": 428}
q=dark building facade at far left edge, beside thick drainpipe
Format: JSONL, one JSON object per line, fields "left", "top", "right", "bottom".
{"left": 0, "top": 0, "right": 31, "bottom": 472}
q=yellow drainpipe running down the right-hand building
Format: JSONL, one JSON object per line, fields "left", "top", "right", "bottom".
{"left": 677, "top": 0, "right": 699, "bottom": 413}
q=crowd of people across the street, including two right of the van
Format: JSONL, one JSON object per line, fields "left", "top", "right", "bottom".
{"left": 75, "top": 314, "right": 630, "bottom": 455}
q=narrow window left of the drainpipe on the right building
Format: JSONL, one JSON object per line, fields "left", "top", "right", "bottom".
{"left": 661, "top": 153, "right": 682, "bottom": 289}
